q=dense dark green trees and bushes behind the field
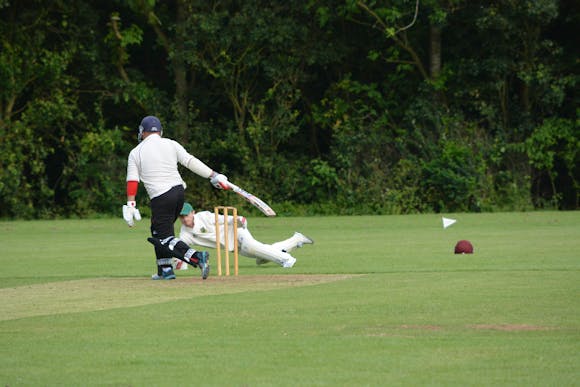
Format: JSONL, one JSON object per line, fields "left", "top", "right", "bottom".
{"left": 0, "top": 0, "right": 580, "bottom": 217}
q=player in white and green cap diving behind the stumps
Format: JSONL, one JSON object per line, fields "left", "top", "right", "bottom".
{"left": 174, "top": 203, "right": 314, "bottom": 269}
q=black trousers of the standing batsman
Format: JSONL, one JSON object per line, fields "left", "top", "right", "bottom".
{"left": 151, "top": 185, "right": 185, "bottom": 259}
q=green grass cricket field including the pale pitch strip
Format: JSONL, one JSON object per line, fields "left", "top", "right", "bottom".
{"left": 0, "top": 212, "right": 580, "bottom": 386}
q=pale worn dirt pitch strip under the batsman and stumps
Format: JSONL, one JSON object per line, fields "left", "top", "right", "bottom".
{"left": 0, "top": 275, "right": 356, "bottom": 321}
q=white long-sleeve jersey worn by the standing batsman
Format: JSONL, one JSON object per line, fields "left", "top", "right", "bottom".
{"left": 127, "top": 134, "right": 212, "bottom": 199}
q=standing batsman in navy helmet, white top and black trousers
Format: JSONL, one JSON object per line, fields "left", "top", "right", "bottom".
{"left": 123, "top": 116, "right": 229, "bottom": 280}
